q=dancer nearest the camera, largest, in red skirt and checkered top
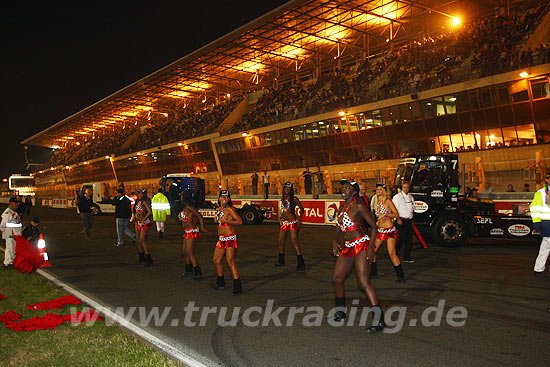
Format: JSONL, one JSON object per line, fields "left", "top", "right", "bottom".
{"left": 332, "top": 180, "right": 386, "bottom": 334}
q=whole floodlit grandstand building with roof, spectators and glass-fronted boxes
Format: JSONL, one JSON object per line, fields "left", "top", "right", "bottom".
{"left": 22, "top": 0, "right": 550, "bottom": 197}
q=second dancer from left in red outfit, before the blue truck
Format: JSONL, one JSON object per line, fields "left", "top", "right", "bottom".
{"left": 179, "top": 191, "right": 208, "bottom": 280}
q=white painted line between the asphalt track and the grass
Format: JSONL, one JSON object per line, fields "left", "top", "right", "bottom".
{"left": 0, "top": 246, "right": 219, "bottom": 367}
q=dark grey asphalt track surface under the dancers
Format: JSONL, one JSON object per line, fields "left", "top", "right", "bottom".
{"left": 5, "top": 208, "right": 550, "bottom": 366}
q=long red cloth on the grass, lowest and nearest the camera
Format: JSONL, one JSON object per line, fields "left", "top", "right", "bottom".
{"left": 4, "top": 310, "right": 103, "bottom": 331}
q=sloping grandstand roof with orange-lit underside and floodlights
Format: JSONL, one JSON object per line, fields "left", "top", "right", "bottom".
{"left": 22, "top": 0, "right": 495, "bottom": 147}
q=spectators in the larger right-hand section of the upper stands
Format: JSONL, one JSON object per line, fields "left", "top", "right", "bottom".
{"left": 233, "top": 4, "right": 550, "bottom": 132}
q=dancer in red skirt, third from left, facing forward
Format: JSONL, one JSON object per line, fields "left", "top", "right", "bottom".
{"left": 212, "top": 190, "right": 243, "bottom": 295}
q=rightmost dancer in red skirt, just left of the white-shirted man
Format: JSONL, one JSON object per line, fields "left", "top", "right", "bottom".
{"left": 372, "top": 183, "right": 405, "bottom": 283}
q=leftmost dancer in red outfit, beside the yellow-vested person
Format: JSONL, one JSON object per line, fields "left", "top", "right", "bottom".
{"left": 130, "top": 189, "right": 153, "bottom": 267}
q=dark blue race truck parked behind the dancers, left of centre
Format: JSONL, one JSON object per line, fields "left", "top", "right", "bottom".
{"left": 160, "top": 173, "right": 272, "bottom": 224}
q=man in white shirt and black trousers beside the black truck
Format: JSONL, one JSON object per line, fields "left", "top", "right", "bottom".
{"left": 392, "top": 181, "right": 414, "bottom": 263}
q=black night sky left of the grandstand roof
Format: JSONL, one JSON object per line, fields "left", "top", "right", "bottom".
{"left": 0, "top": 0, "right": 286, "bottom": 178}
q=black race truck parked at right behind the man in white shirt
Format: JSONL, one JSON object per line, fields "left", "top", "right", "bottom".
{"left": 392, "top": 154, "right": 533, "bottom": 247}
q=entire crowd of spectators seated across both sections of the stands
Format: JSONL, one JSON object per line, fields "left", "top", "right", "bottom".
{"left": 47, "top": 2, "right": 550, "bottom": 166}
